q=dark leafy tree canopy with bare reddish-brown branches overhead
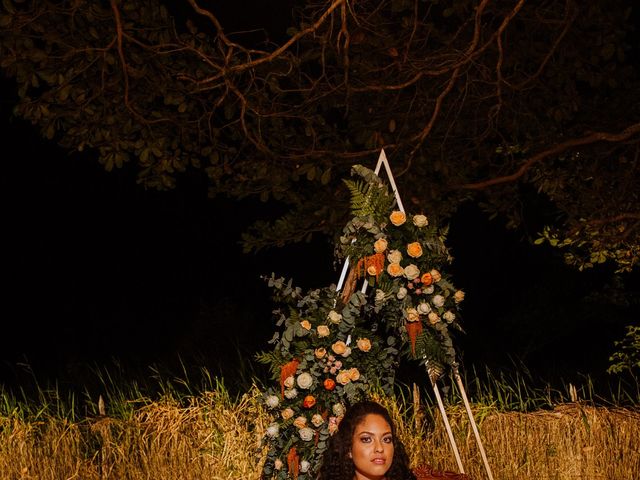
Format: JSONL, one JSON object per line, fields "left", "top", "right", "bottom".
{"left": 0, "top": 0, "right": 640, "bottom": 270}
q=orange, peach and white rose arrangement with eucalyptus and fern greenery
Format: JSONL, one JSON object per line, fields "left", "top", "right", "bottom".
{"left": 257, "top": 165, "right": 464, "bottom": 480}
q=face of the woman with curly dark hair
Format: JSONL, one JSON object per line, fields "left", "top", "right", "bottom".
{"left": 351, "top": 413, "right": 393, "bottom": 480}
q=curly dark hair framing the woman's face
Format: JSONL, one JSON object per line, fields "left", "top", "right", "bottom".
{"left": 317, "top": 401, "right": 416, "bottom": 480}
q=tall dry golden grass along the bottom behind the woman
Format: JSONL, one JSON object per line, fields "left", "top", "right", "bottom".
{"left": 0, "top": 388, "right": 640, "bottom": 480}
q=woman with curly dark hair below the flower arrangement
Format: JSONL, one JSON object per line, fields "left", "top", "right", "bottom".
{"left": 318, "top": 401, "right": 416, "bottom": 480}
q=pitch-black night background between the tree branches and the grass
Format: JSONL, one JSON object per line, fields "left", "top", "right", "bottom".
{"left": 0, "top": 2, "right": 639, "bottom": 394}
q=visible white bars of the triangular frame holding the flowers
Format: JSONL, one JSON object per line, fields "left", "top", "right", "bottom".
{"left": 336, "top": 149, "right": 493, "bottom": 480}
